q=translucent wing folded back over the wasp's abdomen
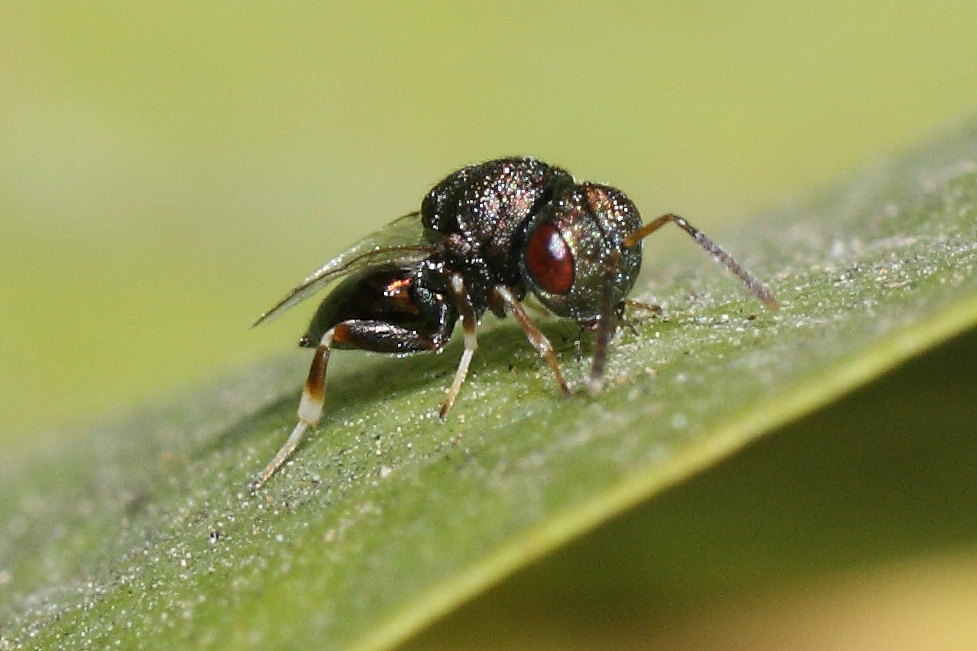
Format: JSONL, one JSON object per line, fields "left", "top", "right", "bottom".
{"left": 251, "top": 211, "right": 434, "bottom": 327}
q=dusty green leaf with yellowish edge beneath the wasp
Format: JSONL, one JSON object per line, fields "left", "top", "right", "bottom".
{"left": 0, "top": 118, "right": 977, "bottom": 648}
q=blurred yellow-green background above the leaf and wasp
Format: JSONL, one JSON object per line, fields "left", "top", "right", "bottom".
{"left": 0, "top": 2, "right": 977, "bottom": 453}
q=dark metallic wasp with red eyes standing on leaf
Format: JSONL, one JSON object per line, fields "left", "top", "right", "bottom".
{"left": 250, "top": 157, "right": 777, "bottom": 492}
